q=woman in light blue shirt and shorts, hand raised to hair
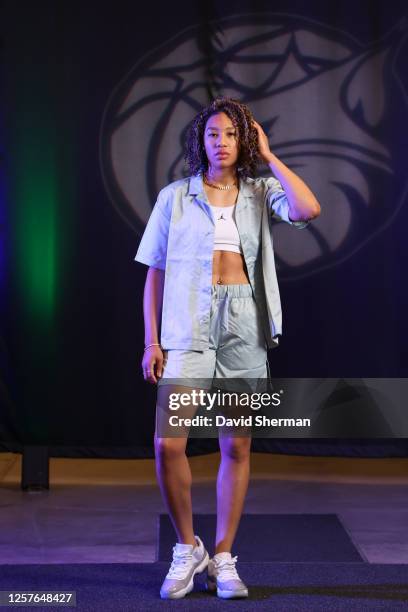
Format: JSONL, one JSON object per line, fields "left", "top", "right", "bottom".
{"left": 135, "top": 97, "right": 320, "bottom": 599}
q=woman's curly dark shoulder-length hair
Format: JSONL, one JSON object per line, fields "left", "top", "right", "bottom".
{"left": 184, "top": 96, "right": 260, "bottom": 178}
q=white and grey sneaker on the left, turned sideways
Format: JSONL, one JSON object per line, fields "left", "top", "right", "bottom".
{"left": 160, "top": 536, "right": 208, "bottom": 599}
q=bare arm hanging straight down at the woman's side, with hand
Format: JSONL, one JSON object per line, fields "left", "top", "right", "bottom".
{"left": 142, "top": 267, "right": 165, "bottom": 383}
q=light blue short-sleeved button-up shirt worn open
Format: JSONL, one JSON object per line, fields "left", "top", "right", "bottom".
{"left": 135, "top": 174, "right": 309, "bottom": 350}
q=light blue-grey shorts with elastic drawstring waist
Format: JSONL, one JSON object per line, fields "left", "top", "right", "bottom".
{"left": 157, "top": 284, "right": 269, "bottom": 389}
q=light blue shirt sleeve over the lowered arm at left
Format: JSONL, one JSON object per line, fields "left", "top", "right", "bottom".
{"left": 135, "top": 190, "right": 170, "bottom": 270}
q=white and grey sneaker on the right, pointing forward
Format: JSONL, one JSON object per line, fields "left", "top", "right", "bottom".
{"left": 207, "top": 552, "right": 248, "bottom": 599}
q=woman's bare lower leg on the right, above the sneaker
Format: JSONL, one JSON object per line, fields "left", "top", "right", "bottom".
{"left": 215, "top": 437, "right": 251, "bottom": 554}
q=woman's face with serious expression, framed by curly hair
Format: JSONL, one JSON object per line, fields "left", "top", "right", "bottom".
{"left": 204, "top": 113, "right": 239, "bottom": 169}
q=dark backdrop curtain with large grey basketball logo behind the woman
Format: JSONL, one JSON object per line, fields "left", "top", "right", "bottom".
{"left": 0, "top": 0, "right": 408, "bottom": 457}
